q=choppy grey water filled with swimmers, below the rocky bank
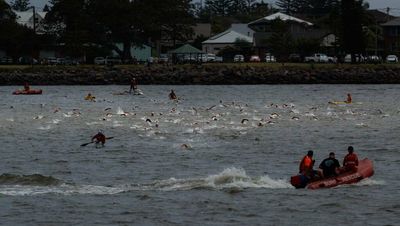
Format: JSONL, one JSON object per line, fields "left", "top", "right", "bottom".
{"left": 0, "top": 85, "right": 400, "bottom": 225}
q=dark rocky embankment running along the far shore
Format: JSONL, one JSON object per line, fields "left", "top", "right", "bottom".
{"left": 0, "top": 64, "right": 400, "bottom": 86}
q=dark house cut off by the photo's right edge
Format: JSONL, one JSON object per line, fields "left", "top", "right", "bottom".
{"left": 381, "top": 17, "right": 400, "bottom": 55}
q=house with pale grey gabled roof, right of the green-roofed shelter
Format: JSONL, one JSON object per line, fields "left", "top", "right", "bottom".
{"left": 202, "top": 24, "right": 254, "bottom": 54}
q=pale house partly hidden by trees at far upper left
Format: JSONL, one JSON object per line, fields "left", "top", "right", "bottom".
{"left": 14, "top": 11, "right": 47, "bottom": 34}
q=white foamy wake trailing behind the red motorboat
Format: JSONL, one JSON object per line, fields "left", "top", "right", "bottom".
{"left": 0, "top": 168, "right": 293, "bottom": 196}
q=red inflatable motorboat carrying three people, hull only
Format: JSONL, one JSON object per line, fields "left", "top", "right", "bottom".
{"left": 290, "top": 158, "right": 374, "bottom": 189}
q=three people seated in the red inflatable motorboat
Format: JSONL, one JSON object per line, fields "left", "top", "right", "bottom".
{"left": 299, "top": 146, "right": 358, "bottom": 180}
